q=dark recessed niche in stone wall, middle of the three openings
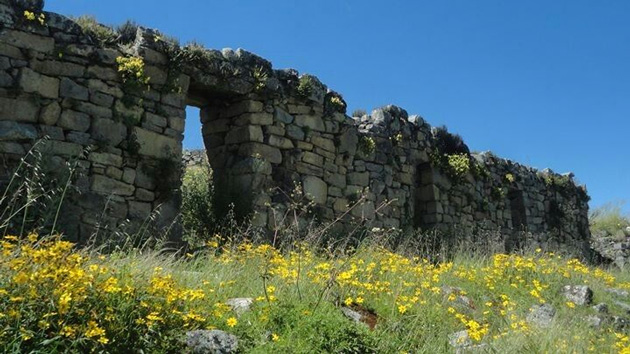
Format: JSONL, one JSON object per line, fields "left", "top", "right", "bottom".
{"left": 413, "top": 163, "right": 442, "bottom": 230}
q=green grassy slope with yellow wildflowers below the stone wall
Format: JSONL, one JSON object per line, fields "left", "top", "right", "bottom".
{"left": 0, "top": 234, "right": 630, "bottom": 353}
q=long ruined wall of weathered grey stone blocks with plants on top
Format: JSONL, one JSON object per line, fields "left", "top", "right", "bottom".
{"left": 0, "top": 0, "right": 590, "bottom": 252}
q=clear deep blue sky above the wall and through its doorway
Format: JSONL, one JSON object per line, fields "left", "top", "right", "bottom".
{"left": 46, "top": 0, "right": 630, "bottom": 211}
